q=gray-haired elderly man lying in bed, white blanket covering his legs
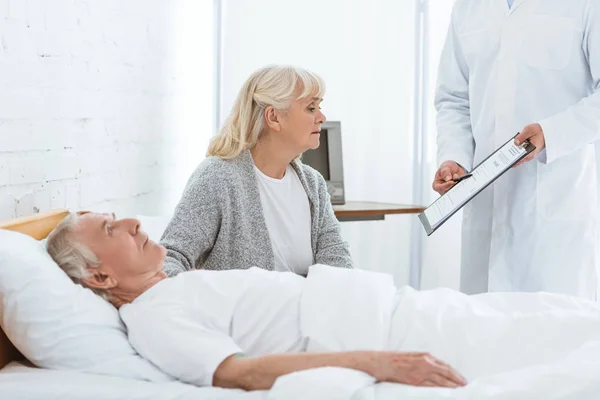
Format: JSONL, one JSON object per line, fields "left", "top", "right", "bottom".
{"left": 48, "top": 213, "right": 600, "bottom": 390}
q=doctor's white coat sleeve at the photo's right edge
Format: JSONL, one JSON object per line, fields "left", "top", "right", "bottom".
{"left": 538, "top": 1, "right": 600, "bottom": 163}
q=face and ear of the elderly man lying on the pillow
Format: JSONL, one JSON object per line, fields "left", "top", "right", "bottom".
{"left": 73, "top": 213, "right": 166, "bottom": 293}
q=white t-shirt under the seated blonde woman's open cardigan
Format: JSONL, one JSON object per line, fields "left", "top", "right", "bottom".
{"left": 254, "top": 165, "right": 313, "bottom": 276}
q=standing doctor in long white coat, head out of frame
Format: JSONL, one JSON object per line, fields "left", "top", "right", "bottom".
{"left": 433, "top": 0, "right": 600, "bottom": 299}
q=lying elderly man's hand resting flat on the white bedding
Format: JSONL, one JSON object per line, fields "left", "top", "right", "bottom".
{"left": 373, "top": 352, "right": 467, "bottom": 388}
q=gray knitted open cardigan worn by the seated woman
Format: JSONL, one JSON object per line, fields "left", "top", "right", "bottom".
{"left": 161, "top": 151, "right": 352, "bottom": 276}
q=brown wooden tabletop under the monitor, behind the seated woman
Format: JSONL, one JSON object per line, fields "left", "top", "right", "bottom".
{"left": 333, "top": 201, "right": 426, "bottom": 222}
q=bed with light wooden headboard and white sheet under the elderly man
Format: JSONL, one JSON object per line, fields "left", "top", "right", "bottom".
{"left": 0, "top": 210, "right": 600, "bottom": 400}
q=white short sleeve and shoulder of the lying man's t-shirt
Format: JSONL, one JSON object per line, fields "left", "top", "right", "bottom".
{"left": 120, "top": 303, "right": 242, "bottom": 386}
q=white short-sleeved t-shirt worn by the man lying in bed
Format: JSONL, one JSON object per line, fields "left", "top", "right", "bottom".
{"left": 119, "top": 267, "right": 307, "bottom": 386}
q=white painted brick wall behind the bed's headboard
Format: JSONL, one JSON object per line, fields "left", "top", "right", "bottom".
{"left": 0, "top": 0, "right": 214, "bottom": 220}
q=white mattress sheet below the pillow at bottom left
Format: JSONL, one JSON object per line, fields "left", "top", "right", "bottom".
{"left": 0, "top": 362, "right": 266, "bottom": 400}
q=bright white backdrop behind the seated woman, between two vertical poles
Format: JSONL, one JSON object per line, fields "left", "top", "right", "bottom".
{"left": 221, "top": 0, "right": 416, "bottom": 284}
